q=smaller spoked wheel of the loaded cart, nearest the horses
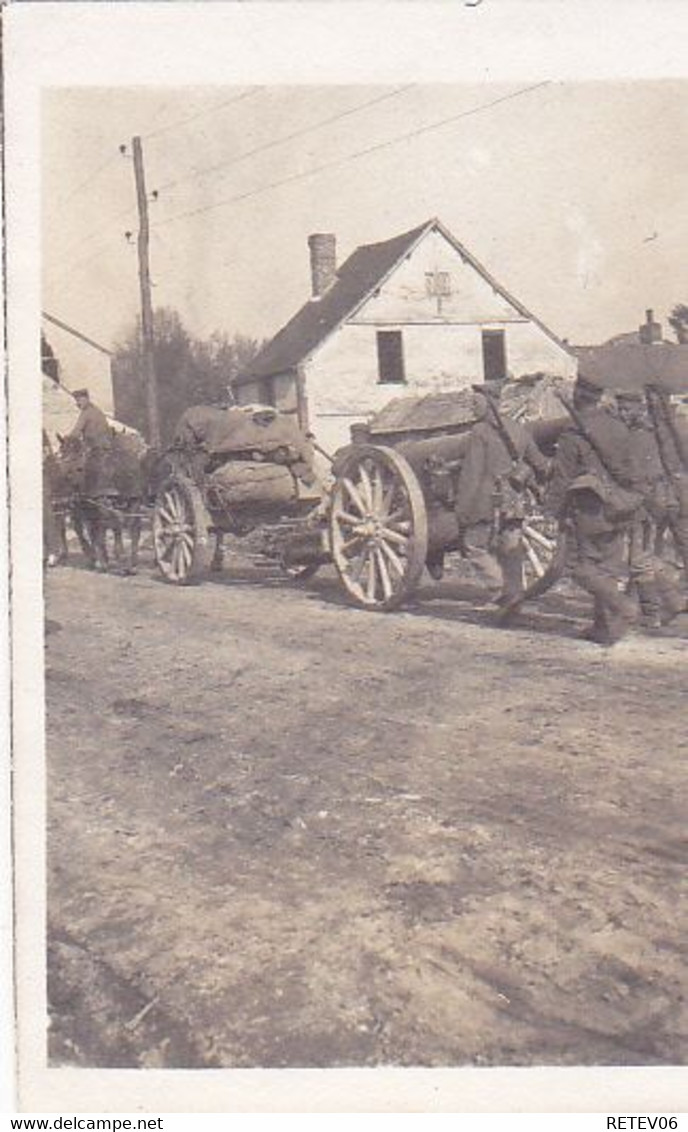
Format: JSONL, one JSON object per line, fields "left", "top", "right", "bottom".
{"left": 153, "top": 475, "right": 210, "bottom": 585}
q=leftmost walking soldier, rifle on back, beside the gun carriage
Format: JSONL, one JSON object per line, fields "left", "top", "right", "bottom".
{"left": 456, "top": 381, "right": 548, "bottom": 612}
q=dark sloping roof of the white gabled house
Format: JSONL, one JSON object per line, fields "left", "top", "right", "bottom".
{"left": 237, "top": 220, "right": 569, "bottom": 384}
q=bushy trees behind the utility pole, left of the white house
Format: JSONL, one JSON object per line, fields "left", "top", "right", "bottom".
{"left": 112, "top": 307, "right": 259, "bottom": 443}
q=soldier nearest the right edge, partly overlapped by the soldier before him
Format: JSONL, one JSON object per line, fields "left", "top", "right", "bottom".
{"left": 617, "top": 391, "right": 686, "bottom": 628}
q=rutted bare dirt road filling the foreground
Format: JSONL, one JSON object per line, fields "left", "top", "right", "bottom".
{"left": 46, "top": 564, "right": 688, "bottom": 1066}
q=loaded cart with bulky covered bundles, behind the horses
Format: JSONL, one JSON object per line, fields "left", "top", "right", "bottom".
{"left": 153, "top": 406, "right": 329, "bottom": 585}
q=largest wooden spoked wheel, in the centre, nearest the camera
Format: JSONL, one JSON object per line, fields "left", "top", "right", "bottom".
{"left": 329, "top": 445, "right": 428, "bottom": 610}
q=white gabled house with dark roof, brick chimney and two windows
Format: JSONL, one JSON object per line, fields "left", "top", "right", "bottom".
{"left": 235, "top": 220, "right": 576, "bottom": 451}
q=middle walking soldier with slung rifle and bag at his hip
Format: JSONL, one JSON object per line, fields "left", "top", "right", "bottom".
{"left": 548, "top": 375, "right": 642, "bottom": 645}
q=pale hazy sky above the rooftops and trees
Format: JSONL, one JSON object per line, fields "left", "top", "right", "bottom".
{"left": 42, "top": 80, "right": 688, "bottom": 371}
